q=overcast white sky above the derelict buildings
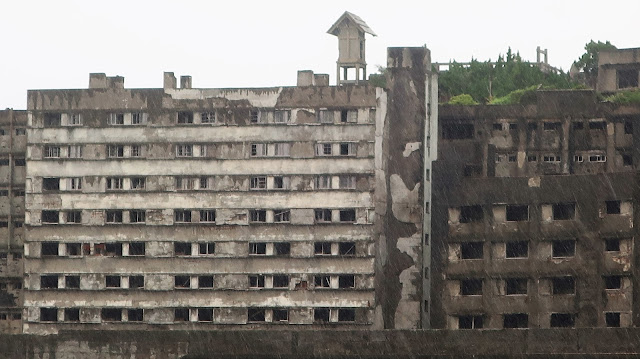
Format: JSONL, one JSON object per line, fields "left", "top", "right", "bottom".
{"left": 0, "top": 0, "right": 640, "bottom": 109}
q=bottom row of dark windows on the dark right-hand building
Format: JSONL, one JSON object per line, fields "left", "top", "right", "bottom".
{"left": 457, "top": 312, "right": 620, "bottom": 329}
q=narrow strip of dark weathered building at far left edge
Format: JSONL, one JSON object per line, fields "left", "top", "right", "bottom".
{"left": 0, "top": 109, "right": 27, "bottom": 333}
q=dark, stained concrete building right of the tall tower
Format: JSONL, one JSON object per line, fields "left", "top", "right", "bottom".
{"left": 431, "top": 91, "right": 640, "bottom": 329}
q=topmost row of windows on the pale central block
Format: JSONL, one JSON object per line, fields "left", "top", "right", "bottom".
{"left": 41, "top": 109, "right": 376, "bottom": 127}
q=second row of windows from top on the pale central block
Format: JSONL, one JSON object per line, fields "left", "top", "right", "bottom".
{"left": 42, "top": 142, "right": 358, "bottom": 159}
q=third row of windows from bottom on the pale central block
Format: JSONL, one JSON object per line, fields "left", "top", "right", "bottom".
{"left": 40, "top": 241, "right": 356, "bottom": 257}
